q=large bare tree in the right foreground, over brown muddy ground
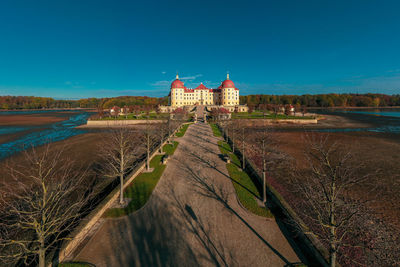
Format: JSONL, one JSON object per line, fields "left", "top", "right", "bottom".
{"left": 292, "top": 135, "right": 376, "bottom": 266}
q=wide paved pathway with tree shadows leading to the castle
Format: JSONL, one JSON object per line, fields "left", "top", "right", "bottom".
{"left": 75, "top": 123, "right": 298, "bottom": 267}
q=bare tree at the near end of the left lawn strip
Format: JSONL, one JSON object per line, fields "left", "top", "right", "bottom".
{"left": 99, "top": 125, "right": 137, "bottom": 205}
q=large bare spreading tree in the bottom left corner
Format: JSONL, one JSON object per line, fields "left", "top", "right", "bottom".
{"left": 0, "top": 145, "right": 93, "bottom": 267}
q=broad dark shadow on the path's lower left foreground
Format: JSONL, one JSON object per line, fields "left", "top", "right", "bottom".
{"left": 91, "top": 195, "right": 199, "bottom": 266}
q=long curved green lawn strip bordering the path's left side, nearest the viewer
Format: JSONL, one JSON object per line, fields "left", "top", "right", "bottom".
{"left": 104, "top": 141, "right": 179, "bottom": 217}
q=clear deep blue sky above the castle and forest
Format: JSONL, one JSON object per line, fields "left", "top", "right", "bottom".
{"left": 0, "top": 0, "right": 400, "bottom": 98}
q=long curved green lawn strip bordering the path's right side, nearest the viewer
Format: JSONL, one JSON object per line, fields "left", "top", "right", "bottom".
{"left": 218, "top": 141, "right": 273, "bottom": 218}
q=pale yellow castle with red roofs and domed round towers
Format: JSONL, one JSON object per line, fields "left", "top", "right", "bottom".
{"left": 168, "top": 74, "right": 239, "bottom": 107}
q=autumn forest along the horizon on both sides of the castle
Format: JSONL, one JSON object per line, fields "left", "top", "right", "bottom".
{"left": 0, "top": 94, "right": 400, "bottom": 110}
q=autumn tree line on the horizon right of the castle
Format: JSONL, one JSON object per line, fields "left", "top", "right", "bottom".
{"left": 240, "top": 93, "right": 400, "bottom": 107}
